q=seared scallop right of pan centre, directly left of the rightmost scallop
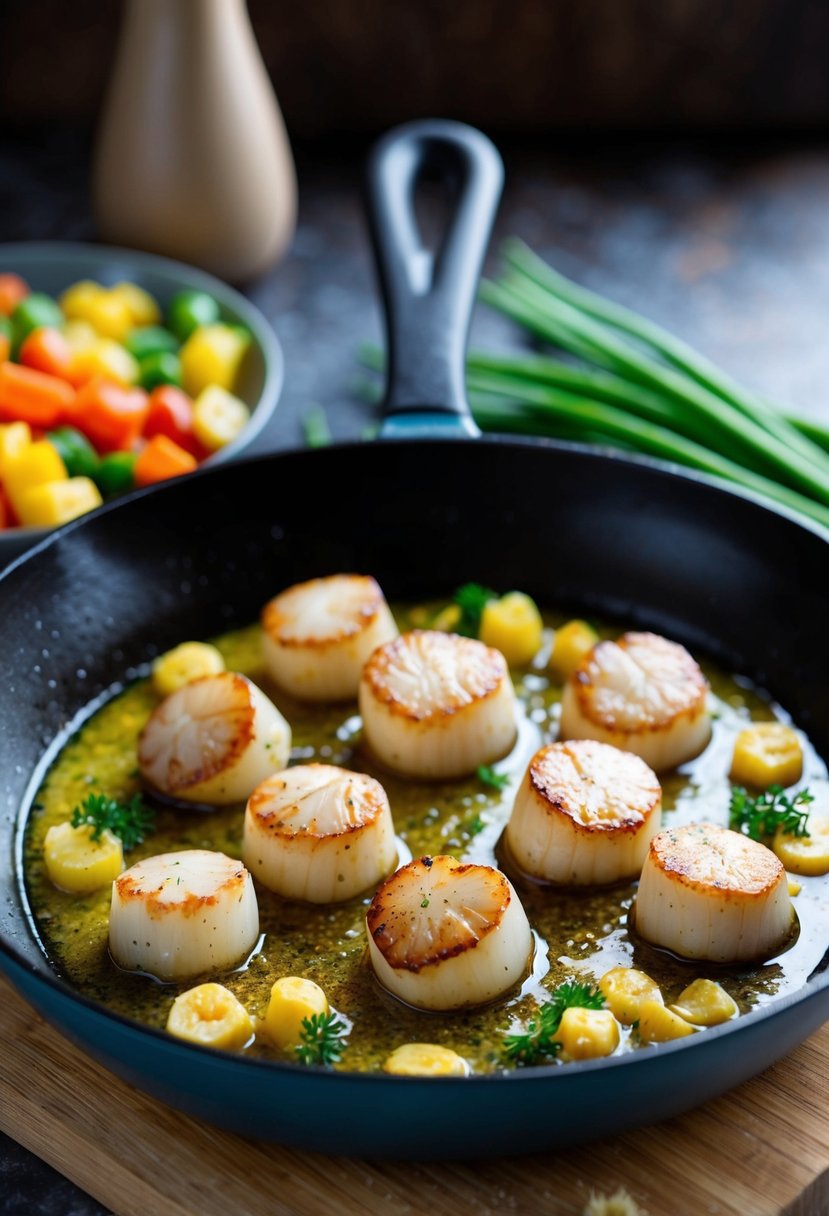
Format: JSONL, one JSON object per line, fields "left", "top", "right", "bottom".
{"left": 506, "top": 739, "right": 662, "bottom": 884}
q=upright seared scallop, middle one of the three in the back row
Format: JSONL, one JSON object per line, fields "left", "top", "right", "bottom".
{"left": 360, "top": 629, "right": 515, "bottom": 779}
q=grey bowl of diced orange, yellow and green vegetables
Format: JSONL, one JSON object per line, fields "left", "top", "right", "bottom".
{"left": 0, "top": 243, "right": 282, "bottom": 564}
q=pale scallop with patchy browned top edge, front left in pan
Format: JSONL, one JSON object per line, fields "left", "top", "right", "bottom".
{"left": 109, "top": 849, "right": 259, "bottom": 980}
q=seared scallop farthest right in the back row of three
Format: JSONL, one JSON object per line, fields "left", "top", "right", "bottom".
{"left": 562, "top": 634, "right": 711, "bottom": 772}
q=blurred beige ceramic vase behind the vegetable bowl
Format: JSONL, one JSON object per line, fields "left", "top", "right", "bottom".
{"left": 92, "top": 0, "right": 297, "bottom": 282}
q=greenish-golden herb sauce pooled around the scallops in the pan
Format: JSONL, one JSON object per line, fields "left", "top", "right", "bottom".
{"left": 23, "top": 606, "right": 829, "bottom": 1073}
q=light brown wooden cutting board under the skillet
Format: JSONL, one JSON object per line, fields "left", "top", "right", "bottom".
{"left": 0, "top": 979, "right": 829, "bottom": 1216}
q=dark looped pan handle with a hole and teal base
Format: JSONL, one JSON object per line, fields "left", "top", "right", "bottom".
{"left": 367, "top": 119, "right": 503, "bottom": 437}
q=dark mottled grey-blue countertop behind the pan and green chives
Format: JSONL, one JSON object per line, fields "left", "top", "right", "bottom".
{"left": 0, "top": 129, "right": 829, "bottom": 1216}
